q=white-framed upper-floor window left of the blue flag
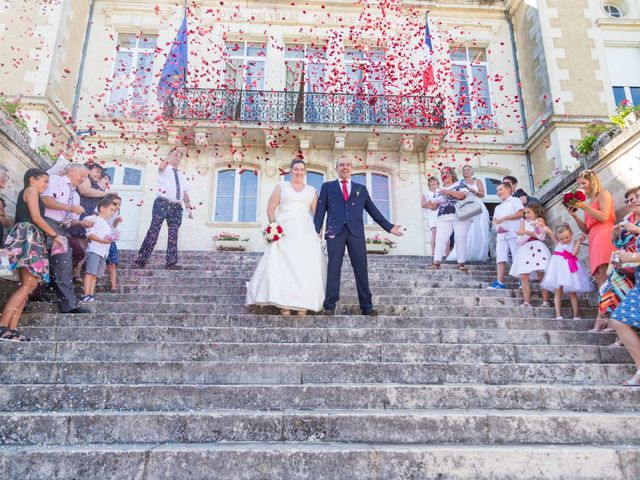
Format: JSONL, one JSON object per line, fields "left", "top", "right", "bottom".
{"left": 106, "top": 32, "right": 158, "bottom": 117}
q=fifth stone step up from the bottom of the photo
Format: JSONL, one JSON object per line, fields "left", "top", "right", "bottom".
{"left": 0, "top": 341, "right": 630, "bottom": 364}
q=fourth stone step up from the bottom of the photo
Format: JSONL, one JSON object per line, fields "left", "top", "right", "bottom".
{"left": 0, "top": 356, "right": 635, "bottom": 386}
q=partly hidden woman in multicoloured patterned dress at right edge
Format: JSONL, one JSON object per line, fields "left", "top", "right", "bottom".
{"left": 598, "top": 187, "right": 640, "bottom": 314}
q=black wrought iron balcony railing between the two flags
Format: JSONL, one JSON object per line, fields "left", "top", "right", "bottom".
{"left": 164, "top": 88, "right": 444, "bottom": 128}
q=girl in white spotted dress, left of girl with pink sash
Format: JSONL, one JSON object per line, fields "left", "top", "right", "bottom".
{"left": 509, "top": 203, "right": 551, "bottom": 307}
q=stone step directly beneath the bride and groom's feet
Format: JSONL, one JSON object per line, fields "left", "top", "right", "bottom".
{"left": 21, "top": 309, "right": 602, "bottom": 335}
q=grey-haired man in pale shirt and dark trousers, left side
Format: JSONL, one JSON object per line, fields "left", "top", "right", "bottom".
{"left": 42, "top": 163, "right": 92, "bottom": 313}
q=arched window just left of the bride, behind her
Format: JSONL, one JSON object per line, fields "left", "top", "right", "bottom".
{"left": 213, "top": 169, "right": 258, "bottom": 222}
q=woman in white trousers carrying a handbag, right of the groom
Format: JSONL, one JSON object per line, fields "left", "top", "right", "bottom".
{"left": 427, "top": 167, "right": 472, "bottom": 272}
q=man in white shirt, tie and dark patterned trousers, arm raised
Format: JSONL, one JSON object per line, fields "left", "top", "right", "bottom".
{"left": 135, "top": 147, "right": 193, "bottom": 269}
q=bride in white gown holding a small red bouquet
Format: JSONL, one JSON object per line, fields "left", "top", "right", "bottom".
{"left": 246, "top": 158, "right": 327, "bottom": 315}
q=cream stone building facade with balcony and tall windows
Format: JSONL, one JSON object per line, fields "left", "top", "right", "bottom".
{"left": 0, "top": 0, "right": 640, "bottom": 255}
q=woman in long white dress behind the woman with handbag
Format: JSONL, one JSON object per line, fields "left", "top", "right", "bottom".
{"left": 447, "top": 165, "right": 490, "bottom": 262}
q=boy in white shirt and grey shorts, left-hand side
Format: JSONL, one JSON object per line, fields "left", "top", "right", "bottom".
{"left": 81, "top": 198, "right": 116, "bottom": 302}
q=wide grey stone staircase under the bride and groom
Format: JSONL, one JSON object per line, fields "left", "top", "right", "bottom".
{"left": 0, "top": 252, "right": 640, "bottom": 480}
